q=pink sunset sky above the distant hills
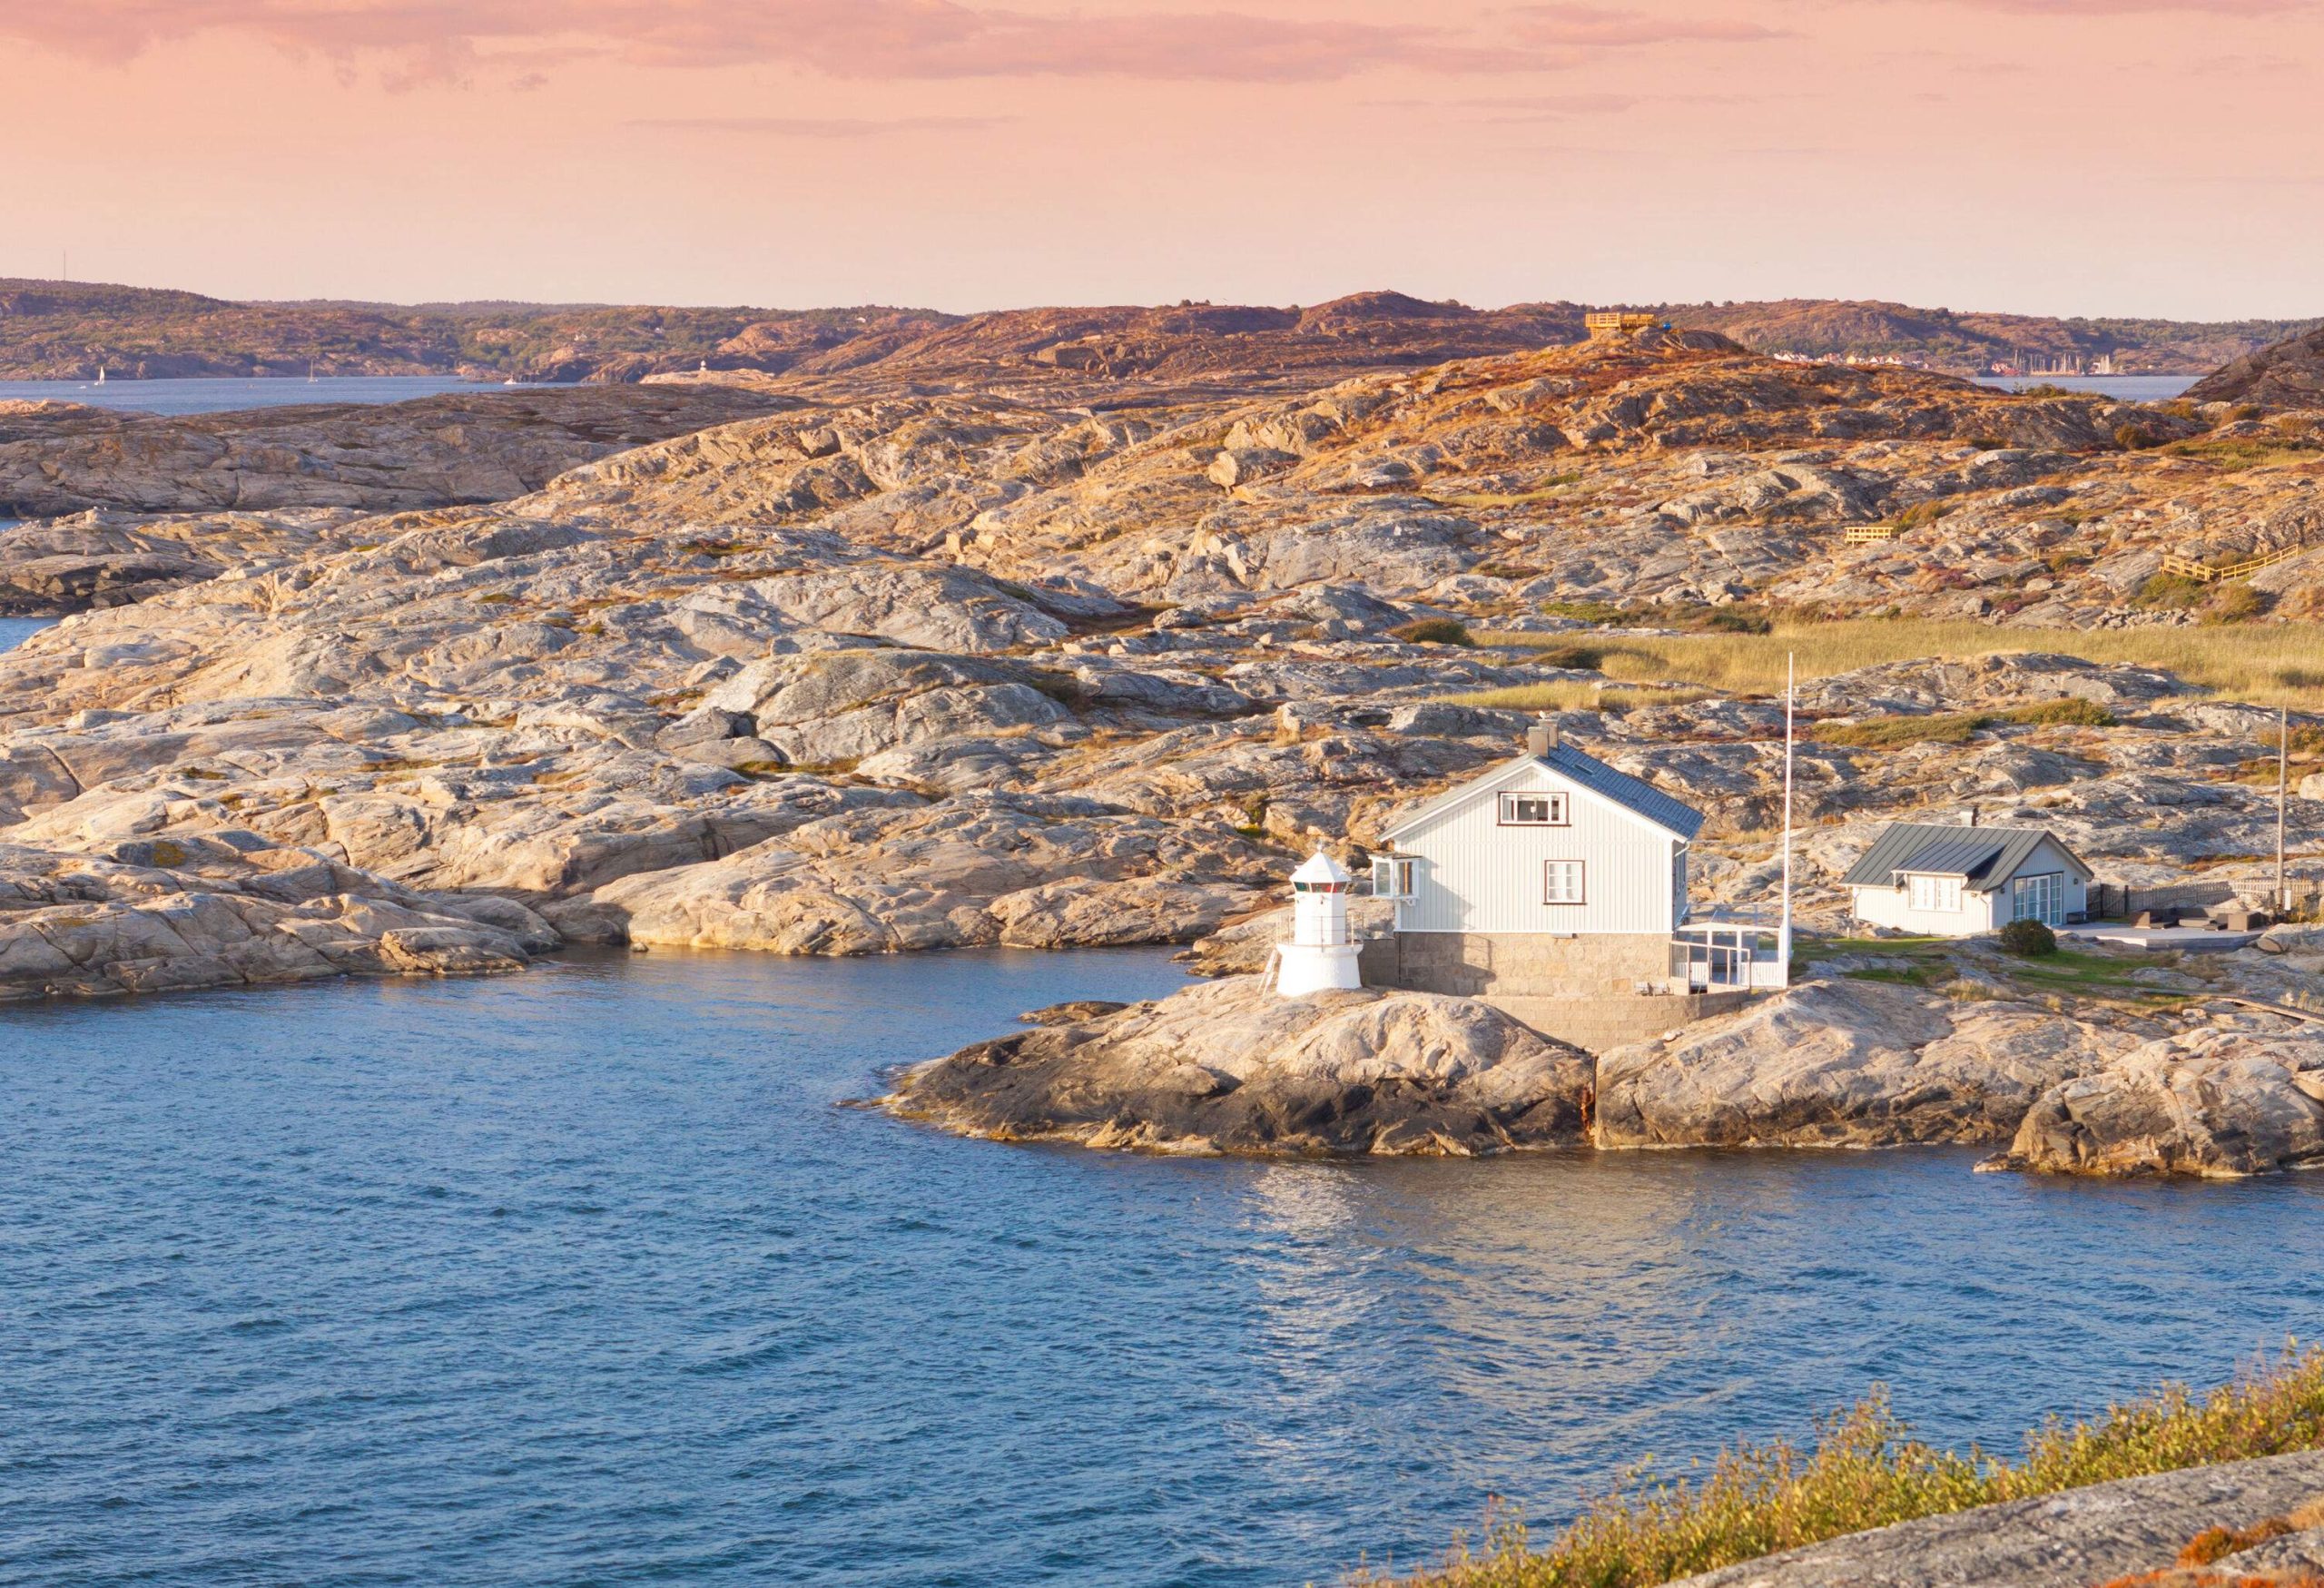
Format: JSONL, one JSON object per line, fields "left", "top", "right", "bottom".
{"left": 0, "top": 0, "right": 2324, "bottom": 319}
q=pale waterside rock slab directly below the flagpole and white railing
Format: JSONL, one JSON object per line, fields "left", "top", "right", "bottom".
{"left": 1594, "top": 981, "right": 2132, "bottom": 1146}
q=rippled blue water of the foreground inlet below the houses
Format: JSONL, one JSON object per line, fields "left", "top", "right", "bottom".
{"left": 0, "top": 951, "right": 2324, "bottom": 1588}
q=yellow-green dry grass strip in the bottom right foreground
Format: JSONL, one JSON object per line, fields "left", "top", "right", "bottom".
{"left": 1360, "top": 1346, "right": 2324, "bottom": 1588}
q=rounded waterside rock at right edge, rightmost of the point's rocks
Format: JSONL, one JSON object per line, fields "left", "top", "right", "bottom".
{"left": 1999, "top": 1030, "right": 2324, "bottom": 1177}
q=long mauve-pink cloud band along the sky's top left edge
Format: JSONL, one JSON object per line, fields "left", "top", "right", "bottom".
{"left": 0, "top": 0, "right": 1534, "bottom": 82}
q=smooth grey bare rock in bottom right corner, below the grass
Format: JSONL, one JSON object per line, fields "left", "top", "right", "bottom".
{"left": 1673, "top": 1451, "right": 2324, "bottom": 1588}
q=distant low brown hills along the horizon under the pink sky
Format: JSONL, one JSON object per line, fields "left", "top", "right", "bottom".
{"left": 0, "top": 279, "right": 2324, "bottom": 381}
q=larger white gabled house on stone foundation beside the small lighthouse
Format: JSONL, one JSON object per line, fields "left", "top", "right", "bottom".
{"left": 1366, "top": 723, "right": 1703, "bottom": 995}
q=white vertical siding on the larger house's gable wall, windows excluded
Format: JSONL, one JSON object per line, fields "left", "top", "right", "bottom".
{"left": 1397, "top": 763, "right": 1682, "bottom": 932}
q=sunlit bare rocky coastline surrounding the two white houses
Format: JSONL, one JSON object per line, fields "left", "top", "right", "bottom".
{"left": 0, "top": 304, "right": 2324, "bottom": 1174}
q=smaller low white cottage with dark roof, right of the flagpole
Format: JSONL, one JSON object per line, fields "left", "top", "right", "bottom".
{"left": 1841, "top": 814, "right": 2092, "bottom": 937}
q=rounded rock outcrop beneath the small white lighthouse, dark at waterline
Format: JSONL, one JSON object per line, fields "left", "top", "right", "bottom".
{"left": 883, "top": 977, "right": 1590, "bottom": 1156}
